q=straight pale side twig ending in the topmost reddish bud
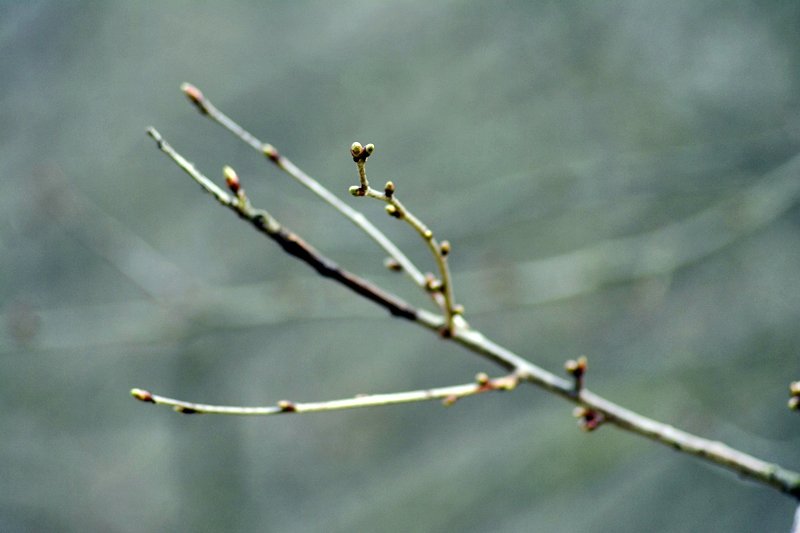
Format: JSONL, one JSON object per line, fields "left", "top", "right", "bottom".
{"left": 181, "top": 83, "right": 432, "bottom": 296}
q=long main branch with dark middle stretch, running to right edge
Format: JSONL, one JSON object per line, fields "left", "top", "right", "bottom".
{"left": 148, "top": 128, "right": 800, "bottom": 499}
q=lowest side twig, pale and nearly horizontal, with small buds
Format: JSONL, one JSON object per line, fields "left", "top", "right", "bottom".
{"left": 131, "top": 374, "right": 519, "bottom": 416}
